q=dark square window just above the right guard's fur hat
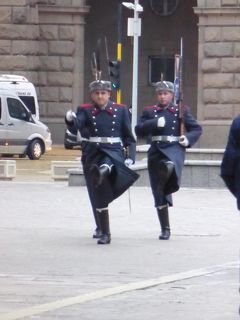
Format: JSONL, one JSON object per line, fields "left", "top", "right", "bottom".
{"left": 148, "top": 56, "right": 175, "bottom": 85}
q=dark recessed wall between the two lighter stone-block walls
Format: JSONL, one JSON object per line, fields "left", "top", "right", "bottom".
{"left": 85, "top": 0, "right": 198, "bottom": 114}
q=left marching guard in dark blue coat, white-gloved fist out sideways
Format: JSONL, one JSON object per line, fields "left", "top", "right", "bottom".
{"left": 66, "top": 80, "right": 138, "bottom": 244}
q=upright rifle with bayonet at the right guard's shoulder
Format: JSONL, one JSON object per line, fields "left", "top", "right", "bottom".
{"left": 174, "top": 38, "right": 185, "bottom": 136}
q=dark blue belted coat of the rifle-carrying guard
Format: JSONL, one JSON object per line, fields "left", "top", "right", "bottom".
{"left": 135, "top": 104, "right": 202, "bottom": 206}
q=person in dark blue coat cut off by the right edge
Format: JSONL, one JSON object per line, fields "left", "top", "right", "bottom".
{"left": 221, "top": 115, "right": 240, "bottom": 210}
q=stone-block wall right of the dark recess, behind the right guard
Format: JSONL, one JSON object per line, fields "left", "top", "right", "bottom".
{"left": 194, "top": 0, "right": 240, "bottom": 148}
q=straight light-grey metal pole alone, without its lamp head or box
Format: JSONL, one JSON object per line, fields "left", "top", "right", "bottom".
{"left": 132, "top": 0, "right": 139, "bottom": 137}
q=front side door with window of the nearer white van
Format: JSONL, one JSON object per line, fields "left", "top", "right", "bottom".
{"left": 6, "top": 97, "right": 35, "bottom": 154}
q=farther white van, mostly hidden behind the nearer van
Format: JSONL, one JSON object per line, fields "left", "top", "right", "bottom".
{"left": 0, "top": 74, "right": 39, "bottom": 120}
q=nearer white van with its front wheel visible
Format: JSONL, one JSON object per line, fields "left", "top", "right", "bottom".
{"left": 0, "top": 87, "right": 52, "bottom": 160}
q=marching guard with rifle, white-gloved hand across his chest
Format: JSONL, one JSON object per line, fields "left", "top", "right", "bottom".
{"left": 135, "top": 81, "right": 202, "bottom": 240}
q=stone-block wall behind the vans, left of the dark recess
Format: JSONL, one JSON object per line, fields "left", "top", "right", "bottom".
{"left": 0, "top": 0, "right": 89, "bottom": 143}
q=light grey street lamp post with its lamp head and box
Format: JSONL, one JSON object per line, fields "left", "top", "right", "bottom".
{"left": 122, "top": 0, "right": 143, "bottom": 136}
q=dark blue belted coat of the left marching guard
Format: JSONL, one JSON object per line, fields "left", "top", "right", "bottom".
{"left": 72, "top": 101, "right": 138, "bottom": 208}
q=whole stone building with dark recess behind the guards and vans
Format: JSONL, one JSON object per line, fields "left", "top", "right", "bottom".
{"left": 0, "top": 0, "right": 240, "bottom": 148}
